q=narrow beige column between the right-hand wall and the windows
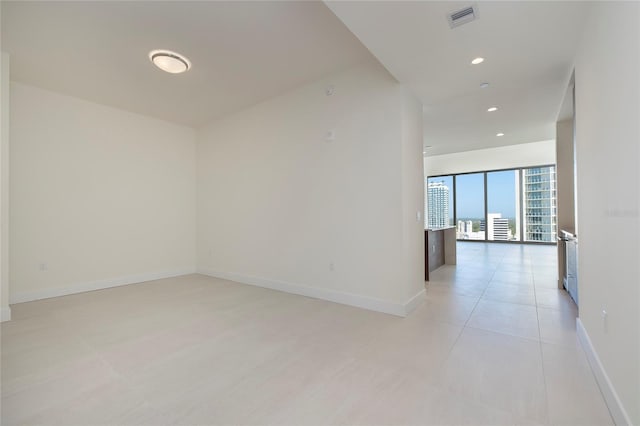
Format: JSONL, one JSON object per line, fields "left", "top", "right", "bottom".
{"left": 556, "top": 118, "right": 575, "bottom": 288}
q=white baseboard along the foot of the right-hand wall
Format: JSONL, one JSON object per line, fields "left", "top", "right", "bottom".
{"left": 576, "top": 318, "right": 633, "bottom": 426}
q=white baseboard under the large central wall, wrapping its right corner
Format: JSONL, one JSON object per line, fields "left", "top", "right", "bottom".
{"left": 198, "top": 268, "right": 425, "bottom": 317}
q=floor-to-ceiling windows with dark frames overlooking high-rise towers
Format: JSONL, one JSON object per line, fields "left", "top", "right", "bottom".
{"left": 425, "top": 165, "right": 557, "bottom": 243}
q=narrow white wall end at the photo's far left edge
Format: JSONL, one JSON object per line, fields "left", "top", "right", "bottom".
{"left": 0, "top": 52, "right": 11, "bottom": 321}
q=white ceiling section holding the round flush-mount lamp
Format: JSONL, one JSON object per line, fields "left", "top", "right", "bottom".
{"left": 1, "top": 1, "right": 371, "bottom": 126}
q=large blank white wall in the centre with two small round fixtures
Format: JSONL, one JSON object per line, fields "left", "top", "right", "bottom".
{"left": 198, "top": 63, "right": 424, "bottom": 315}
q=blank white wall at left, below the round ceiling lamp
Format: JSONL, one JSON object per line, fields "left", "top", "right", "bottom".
{"left": 10, "top": 83, "right": 196, "bottom": 303}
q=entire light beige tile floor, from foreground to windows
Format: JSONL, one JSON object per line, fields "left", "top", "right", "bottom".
{"left": 1, "top": 243, "right": 612, "bottom": 425}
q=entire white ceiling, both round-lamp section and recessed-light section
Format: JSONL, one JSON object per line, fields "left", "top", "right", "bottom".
{"left": 1, "top": 1, "right": 587, "bottom": 155}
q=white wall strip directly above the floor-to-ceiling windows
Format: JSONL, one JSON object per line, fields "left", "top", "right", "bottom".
{"left": 424, "top": 141, "right": 556, "bottom": 176}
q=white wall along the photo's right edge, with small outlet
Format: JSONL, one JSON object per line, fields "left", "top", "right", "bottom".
{"left": 575, "top": 2, "right": 640, "bottom": 424}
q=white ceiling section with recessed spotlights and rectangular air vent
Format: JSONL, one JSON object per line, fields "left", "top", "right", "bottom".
{"left": 327, "top": 0, "right": 587, "bottom": 155}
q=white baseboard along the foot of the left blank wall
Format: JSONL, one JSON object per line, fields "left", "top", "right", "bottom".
{"left": 9, "top": 268, "right": 196, "bottom": 305}
